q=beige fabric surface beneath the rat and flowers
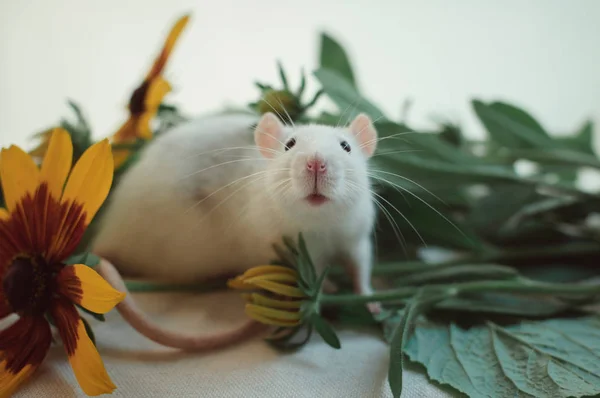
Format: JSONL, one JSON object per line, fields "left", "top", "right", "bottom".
{"left": 15, "top": 292, "right": 453, "bottom": 398}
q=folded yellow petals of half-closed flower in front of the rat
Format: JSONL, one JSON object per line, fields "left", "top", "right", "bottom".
{"left": 228, "top": 265, "right": 307, "bottom": 327}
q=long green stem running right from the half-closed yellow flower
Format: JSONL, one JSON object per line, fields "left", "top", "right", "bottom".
{"left": 320, "top": 278, "right": 600, "bottom": 305}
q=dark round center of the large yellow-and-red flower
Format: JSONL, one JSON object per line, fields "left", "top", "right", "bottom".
{"left": 2, "top": 257, "right": 52, "bottom": 315}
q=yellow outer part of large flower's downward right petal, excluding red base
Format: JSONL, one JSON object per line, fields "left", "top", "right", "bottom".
{"left": 69, "top": 319, "right": 117, "bottom": 396}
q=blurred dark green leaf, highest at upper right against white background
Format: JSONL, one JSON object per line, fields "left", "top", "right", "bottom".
{"left": 472, "top": 100, "right": 557, "bottom": 148}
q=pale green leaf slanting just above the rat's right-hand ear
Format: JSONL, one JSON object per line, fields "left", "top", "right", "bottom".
{"left": 314, "top": 68, "right": 385, "bottom": 122}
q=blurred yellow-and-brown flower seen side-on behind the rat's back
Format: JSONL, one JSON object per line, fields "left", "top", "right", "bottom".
{"left": 112, "top": 15, "right": 189, "bottom": 168}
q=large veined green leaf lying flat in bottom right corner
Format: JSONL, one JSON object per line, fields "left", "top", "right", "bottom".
{"left": 406, "top": 318, "right": 600, "bottom": 398}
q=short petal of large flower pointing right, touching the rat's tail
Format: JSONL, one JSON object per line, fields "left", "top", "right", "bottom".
{"left": 57, "top": 264, "right": 125, "bottom": 314}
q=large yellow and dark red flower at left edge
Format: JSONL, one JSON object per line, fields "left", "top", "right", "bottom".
{"left": 0, "top": 129, "right": 124, "bottom": 397}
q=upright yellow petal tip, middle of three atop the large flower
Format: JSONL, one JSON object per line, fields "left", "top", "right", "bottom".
{"left": 41, "top": 128, "right": 73, "bottom": 199}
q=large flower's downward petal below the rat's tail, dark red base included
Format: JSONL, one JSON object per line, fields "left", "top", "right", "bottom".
{"left": 50, "top": 298, "right": 116, "bottom": 396}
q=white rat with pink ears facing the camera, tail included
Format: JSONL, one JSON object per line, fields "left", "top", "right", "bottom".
{"left": 93, "top": 113, "right": 377, "bottom": 350}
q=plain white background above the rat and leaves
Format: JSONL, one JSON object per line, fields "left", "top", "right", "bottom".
{"left": 0, "top": 0, "right": 600, "bottom": 151}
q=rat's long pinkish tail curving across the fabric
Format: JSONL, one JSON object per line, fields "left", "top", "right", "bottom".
{"left": 96, "top": 259, "right": 266, "bottom": 351}
